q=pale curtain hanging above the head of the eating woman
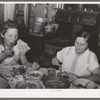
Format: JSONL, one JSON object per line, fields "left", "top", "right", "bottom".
{"left": 4, "top": 4, "right": 15, "bottom": 21}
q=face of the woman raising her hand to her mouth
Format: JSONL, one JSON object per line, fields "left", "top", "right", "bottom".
{"left": 4, "top": 28, "right": 18, "bottom": 46}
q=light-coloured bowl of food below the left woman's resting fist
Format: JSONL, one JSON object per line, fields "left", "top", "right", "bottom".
{"left": 29, "top": 70, "right": 44, "bottom": 82}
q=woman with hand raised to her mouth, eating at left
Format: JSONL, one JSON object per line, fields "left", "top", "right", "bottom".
{"left": 0, "top": 20, "right": 39, "bottom": 88}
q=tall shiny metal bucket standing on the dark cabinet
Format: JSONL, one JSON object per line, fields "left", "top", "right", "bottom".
{"left": 33, "top": 17, "right": 46, "bottom": 33}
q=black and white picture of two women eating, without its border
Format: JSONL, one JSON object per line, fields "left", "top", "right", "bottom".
{"left": 0, "top": 2, "right": 100, "bottom": 91}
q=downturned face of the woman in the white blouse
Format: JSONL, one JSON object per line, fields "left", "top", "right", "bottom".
{"left": 75, "top": 37, "right": 88, "bottom": 54}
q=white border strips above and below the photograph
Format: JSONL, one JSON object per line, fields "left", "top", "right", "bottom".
{"left": 0, "top": 1, "right": 100, "bottom": 98}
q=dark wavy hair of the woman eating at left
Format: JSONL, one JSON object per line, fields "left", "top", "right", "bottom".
{"left": 0, "top": 19, "right": 18, "bottom": 43}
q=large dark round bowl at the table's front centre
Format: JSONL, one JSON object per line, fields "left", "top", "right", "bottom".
{"left": 42, "top": 75, "right": 70, "bottom": 89}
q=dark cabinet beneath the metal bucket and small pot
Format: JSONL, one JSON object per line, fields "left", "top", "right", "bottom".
{"left": 28, "top": 32, "right": 52, "bottom": 55}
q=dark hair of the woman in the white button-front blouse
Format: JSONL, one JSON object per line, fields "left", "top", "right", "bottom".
{"left": 75, "top": 30, "right": 90, "bottom": 44}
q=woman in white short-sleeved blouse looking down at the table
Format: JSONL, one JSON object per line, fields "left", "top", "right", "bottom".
{"left": 52, "top": 30, "right": 100, "bottom": 88}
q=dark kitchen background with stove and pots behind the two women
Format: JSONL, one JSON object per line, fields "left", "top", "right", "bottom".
{"left": 0, "top": 3, "right": 100, "bottom": 88}
